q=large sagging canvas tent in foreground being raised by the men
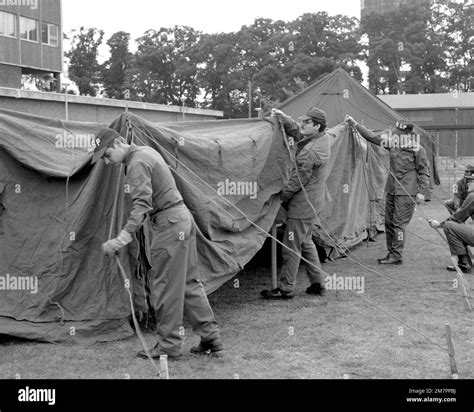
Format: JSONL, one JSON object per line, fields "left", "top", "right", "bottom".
{"left": 0, "top": 100, "right": 386, "bottom": 343}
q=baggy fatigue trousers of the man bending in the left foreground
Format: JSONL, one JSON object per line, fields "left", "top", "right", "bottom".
{"left": 149, "top": 206, "right": 219, "bottom": 354}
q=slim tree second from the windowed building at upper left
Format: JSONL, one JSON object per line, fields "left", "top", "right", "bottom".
{"left": 101, "top": 31, "right": 137, "bottom": 100}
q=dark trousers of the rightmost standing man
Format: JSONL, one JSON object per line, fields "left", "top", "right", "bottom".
{"left": 385, "top": 194, "right": 416, "bottom": 260}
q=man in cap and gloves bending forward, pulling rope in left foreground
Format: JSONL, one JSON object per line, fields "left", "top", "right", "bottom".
{"left": 92, "top": 129, "right": 223, "bottom": 359}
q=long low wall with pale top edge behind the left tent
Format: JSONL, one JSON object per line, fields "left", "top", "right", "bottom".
{"left": 0, "top": 88, "right": 224, "bottom": 123}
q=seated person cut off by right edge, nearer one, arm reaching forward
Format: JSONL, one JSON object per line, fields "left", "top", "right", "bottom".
{"left": 430, "top": 193, "right": 474, "bottom": 273}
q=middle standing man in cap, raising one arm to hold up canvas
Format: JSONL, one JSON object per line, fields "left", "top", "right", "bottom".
{"left": 262, "top": 107, "right": 331, "bottom": 299}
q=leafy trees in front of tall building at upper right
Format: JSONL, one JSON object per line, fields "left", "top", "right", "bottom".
{"left": 362, "top": 0, "right": 473, "bottom": 94}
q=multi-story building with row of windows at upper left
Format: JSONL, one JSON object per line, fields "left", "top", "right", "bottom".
{"left": 0, "top": 0, "right": 63, "bottom": 90}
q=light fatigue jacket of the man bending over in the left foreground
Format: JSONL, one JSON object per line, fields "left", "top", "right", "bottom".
{"left": 124, "top": 144, "right": 183, "bottom": 233}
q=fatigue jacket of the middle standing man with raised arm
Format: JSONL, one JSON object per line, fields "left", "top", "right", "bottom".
{"left": 282, "top": 116, "right": 331, "bottom": 219}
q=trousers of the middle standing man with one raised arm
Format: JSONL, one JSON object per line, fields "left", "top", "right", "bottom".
{"left": 278, "top": 218, "right": 324, "bottom": 292}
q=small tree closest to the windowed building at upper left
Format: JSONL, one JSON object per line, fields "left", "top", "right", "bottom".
{"left": 65, "top": 27, "right": 104, "bottom": 96}
